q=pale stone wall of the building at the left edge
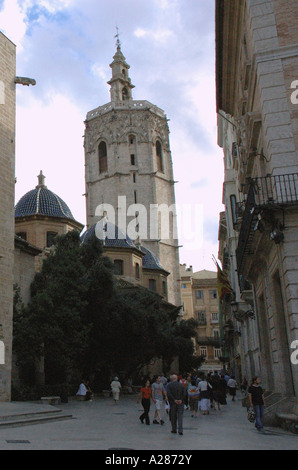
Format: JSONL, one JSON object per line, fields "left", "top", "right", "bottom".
{"left": 0, "top": 32, "right": 16, "bottom": 401}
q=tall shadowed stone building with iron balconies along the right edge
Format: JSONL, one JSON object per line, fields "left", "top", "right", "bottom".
{"left": 216, "top": 0, "right": 298, "bottom": 404}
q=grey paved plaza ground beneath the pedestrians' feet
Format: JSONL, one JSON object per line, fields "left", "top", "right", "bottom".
{"left": 0, "top": 395, "right": 298, "bottom": 452}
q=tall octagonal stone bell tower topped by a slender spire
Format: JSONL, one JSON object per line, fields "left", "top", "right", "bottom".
{"left": 84, "top": 40, "right": 181, "bottom": 305}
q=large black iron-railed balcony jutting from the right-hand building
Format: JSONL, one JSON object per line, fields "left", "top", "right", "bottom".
{"left": 236, "top": 173, "right": 298, "bottom": 275}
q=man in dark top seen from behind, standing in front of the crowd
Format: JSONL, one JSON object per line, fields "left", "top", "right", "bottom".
{"left": 167, "top": 374, "right": 186, "bottom": 436}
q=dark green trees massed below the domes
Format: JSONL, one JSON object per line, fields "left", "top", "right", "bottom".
{"left": 14, "top": 232, "right": 196, "bottom": 386}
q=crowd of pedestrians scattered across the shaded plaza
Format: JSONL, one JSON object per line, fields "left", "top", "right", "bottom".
{"left": 77, "top": 371, "right": 265, "bottom": 435}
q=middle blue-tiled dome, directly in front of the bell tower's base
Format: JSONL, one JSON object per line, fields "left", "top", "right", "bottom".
{"left": 81, "top": 221, "right": 136, "bottom": 252}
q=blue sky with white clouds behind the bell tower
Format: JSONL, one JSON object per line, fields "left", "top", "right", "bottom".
{"left": 0, "top": 0, "right": 224, "bottom": 271}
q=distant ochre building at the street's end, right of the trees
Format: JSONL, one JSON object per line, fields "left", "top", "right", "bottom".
{"left": 180, "top": 264, "right": 223, "bottom": 372}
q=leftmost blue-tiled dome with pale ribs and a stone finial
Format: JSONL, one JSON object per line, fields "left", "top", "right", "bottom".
{"left": 15, "top": 172, "right": 74, "bottom": 220}
